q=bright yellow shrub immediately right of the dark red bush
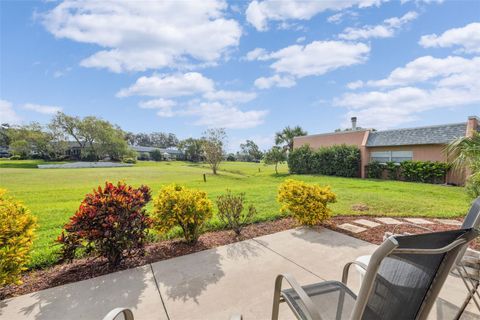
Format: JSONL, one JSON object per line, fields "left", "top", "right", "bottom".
{"left": 151, "top": 184, "right": 213, "bottom": 243}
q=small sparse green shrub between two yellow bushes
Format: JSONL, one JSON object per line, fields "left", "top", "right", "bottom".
{"left": 217, "top": 189, "right": 257, "bottom": 235}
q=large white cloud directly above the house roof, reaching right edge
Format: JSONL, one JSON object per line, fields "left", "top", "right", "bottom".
{"left": 334, "top": 56, "right": 480, "bottom": 129}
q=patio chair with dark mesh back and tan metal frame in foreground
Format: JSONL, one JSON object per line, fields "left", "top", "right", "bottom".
{"left": 272, "top": 229, "right": 478, "bottom": 320}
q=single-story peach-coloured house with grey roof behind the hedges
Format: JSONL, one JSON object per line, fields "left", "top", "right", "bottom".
{"left": 293, "top": 116, "right": 480, "bottom": 185}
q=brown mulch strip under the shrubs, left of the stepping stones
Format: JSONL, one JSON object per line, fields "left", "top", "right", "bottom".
{"left": 0, "top": 218, "right": 297, "bottom": 300}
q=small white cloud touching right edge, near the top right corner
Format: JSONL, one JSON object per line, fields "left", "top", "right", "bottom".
{"left": 419, "top": 22, "right": 480, "bottom": 53}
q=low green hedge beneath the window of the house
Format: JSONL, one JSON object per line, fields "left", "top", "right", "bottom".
{"left": 366, "top": 161, "right": 450, "bottom": 183}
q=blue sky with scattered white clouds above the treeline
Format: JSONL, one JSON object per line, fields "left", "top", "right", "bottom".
{"left": 0, "top": 0, "right": 480, "bottom": 150}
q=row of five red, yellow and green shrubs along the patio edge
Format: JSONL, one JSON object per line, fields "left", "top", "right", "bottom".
{"left": 0, "top": 179, "right": 336, "bottom": 287}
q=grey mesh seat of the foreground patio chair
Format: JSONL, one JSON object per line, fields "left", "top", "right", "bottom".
{"left": 281, "top": 281, "right": 357, "bottom": 320}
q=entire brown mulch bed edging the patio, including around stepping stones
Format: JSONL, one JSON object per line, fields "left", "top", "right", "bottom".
{"left": 0, "top": 215, "right": 480, "bottom": 300}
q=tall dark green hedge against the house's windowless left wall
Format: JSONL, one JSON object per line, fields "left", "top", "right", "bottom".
{"left": 288, "top": 145, "right": 360, "bottom": 177}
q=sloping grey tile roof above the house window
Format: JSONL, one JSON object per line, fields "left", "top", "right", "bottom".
{"left": 367, "top": 122, "right": 467, "bottom": 147}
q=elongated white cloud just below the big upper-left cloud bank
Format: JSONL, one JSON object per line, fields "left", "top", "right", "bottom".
{"left": 117, "top": 72, "right": 214, "bottom": 98}
